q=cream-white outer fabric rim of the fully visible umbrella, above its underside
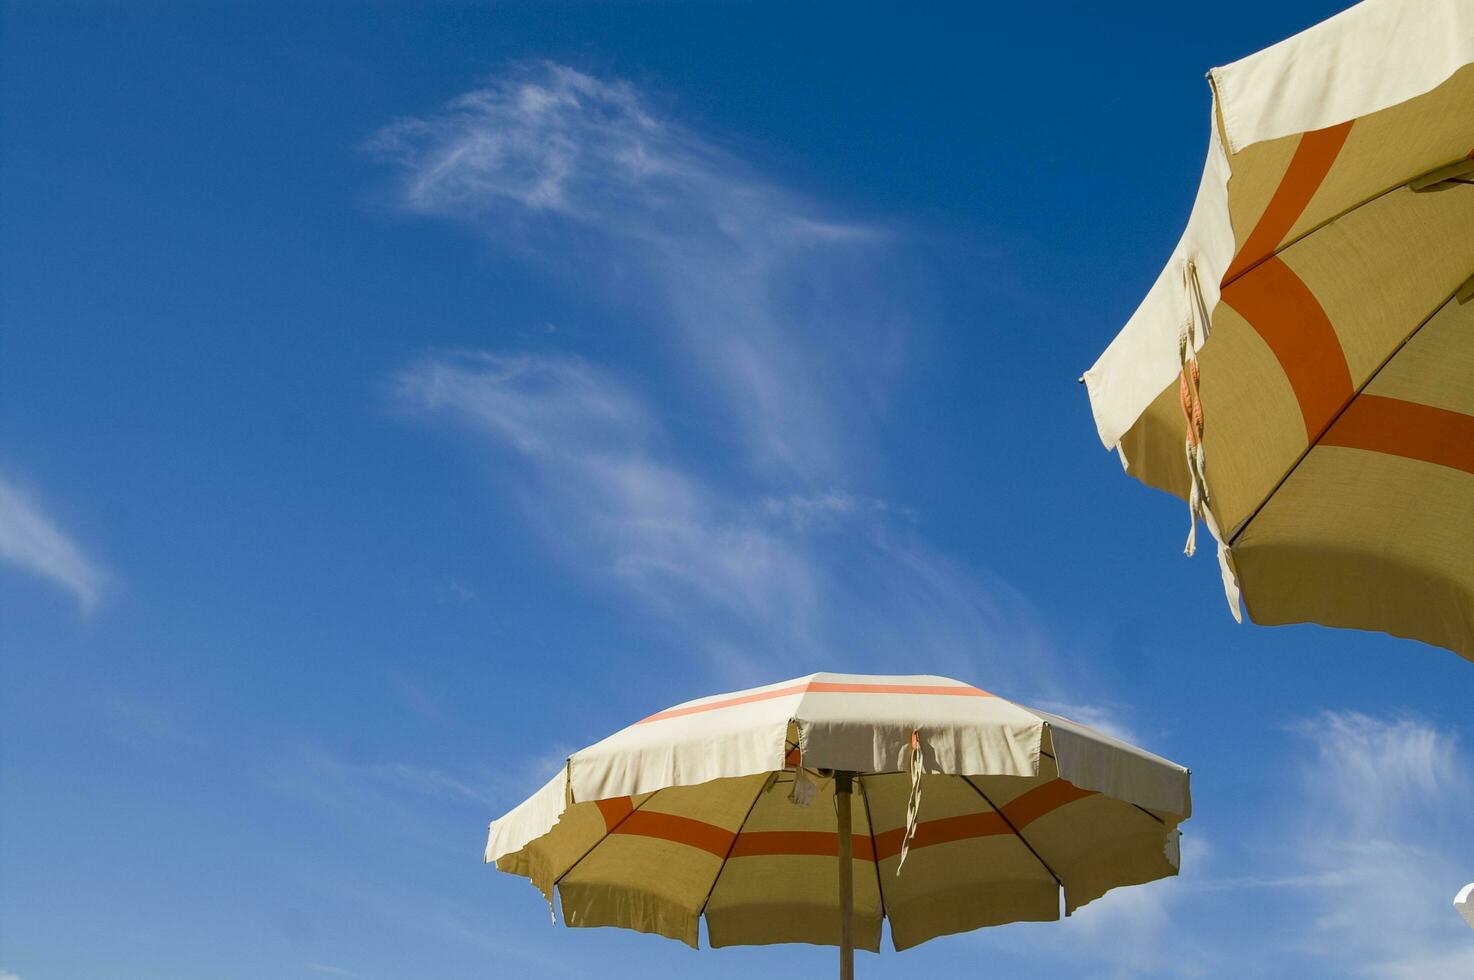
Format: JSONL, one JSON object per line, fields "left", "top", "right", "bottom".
{"left": 485, "top": 673, "right": 1191, "bottom": 864}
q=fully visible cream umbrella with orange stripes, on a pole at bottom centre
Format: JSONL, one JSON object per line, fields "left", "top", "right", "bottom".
{"left": 486, "top": 673, "right": 1190, "bottom": 977}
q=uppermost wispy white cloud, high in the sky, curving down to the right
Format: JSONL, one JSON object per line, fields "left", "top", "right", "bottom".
{"left": 371, "top": 63, "right": 905, "bottom": 477}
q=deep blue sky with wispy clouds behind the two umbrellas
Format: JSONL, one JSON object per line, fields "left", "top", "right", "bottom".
{"left": 0, "top": 0, "right": 1474, "bottom": 980}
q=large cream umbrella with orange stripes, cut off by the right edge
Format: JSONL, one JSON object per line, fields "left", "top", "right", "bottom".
{"left": 1082, "top": 0, "right": 1474, "bottom": 659}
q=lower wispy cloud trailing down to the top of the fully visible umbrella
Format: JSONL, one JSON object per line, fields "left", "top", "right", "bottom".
{"left": 397, "top": 354, "right": 1048, "bottom": 684}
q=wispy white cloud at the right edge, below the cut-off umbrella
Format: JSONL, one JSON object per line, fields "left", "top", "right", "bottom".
{"left": 1190, "top": 712, "right": 1474, "bottom": 980}
